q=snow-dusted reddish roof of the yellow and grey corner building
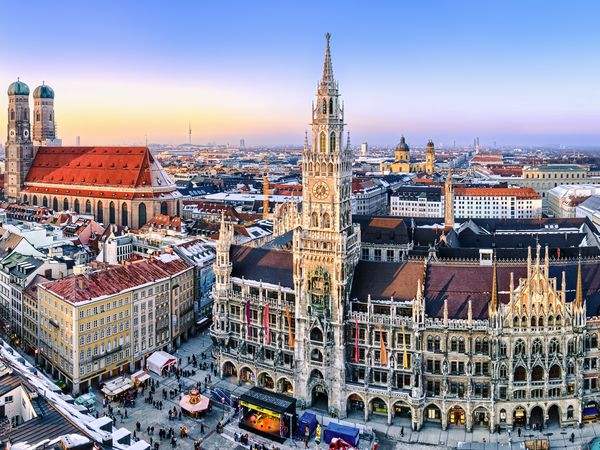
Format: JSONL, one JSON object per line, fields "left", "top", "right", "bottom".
{"left": 44, "top": 257, "right": 191, "bottom": 303}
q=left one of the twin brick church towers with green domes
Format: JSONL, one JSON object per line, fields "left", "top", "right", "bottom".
{"left": 4, "top": 80, "right": 33, "bottom": 202}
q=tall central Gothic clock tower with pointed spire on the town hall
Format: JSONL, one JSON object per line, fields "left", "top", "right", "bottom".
{"left": 294, "top": 33, "right": 360, "bottom": 413}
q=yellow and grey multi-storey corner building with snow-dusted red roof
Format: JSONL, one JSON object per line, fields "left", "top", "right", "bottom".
{"left": 37, "top": 254, "right": 194, "bottom": 394}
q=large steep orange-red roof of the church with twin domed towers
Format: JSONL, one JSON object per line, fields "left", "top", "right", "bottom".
{"left": 25, "top": 147, "right": 166, "bottom": 189}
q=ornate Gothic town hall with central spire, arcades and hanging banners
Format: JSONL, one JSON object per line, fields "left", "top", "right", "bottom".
{"left": 211, "top": 36, "right": 600, "bottom": 430}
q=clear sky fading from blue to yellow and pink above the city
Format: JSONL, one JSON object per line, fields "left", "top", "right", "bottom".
{"left": 0, "top": 1, "right": 600, "bottom": 146}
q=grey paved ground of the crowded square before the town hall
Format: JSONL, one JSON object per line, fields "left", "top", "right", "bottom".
{"left": 18, "top": 332, "right": 600, "bottom": 450}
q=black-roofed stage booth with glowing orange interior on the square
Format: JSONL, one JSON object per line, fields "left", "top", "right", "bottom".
{"left": 239, "top": 387, "right": 296, "bottom": 443}
